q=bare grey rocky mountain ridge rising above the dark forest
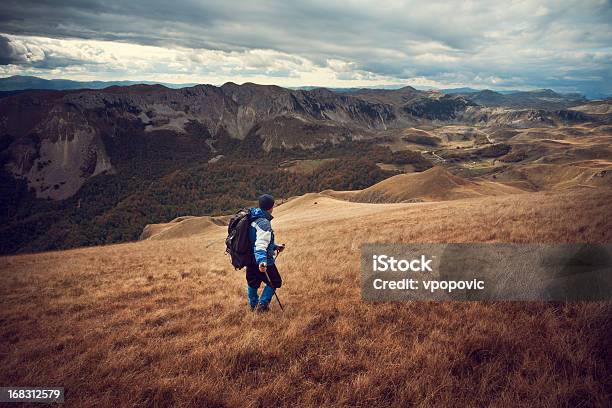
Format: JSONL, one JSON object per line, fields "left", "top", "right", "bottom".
{"left": 0, "top": 83, "right": 589, "bottom": 199}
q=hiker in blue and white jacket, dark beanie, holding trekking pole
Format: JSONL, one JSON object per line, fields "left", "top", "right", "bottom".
{"left": 246, "top": 194, "right": 285, "bottom": 312}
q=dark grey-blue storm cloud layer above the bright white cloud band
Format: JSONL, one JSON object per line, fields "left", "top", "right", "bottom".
{"left": 0, "top": 0, "right": 612, "bottom": 93}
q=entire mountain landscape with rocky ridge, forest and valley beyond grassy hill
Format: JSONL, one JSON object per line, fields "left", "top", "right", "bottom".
{"left": 0, "top": 78, "right": 612, "bottom": 252}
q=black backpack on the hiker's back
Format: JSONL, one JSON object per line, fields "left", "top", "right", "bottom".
{"left": 225, "top": 208, "right": 254, "bottom": 269}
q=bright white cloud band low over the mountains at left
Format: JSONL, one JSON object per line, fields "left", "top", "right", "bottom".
{"left": 0, "top": 35, "right": 408, "bottom": 86}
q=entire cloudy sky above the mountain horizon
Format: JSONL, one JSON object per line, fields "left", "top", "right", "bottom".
{"left": 0, "top": 0, "right": 612, "bottom": 95}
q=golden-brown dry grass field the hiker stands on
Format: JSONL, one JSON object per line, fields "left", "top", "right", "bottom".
{"left": 0, "top": 187, "right": 612, "bottom": 407}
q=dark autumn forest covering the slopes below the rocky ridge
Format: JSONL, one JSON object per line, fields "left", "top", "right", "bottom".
{"left": 0, "top": 132, "right": 431, "bottom": 254}
